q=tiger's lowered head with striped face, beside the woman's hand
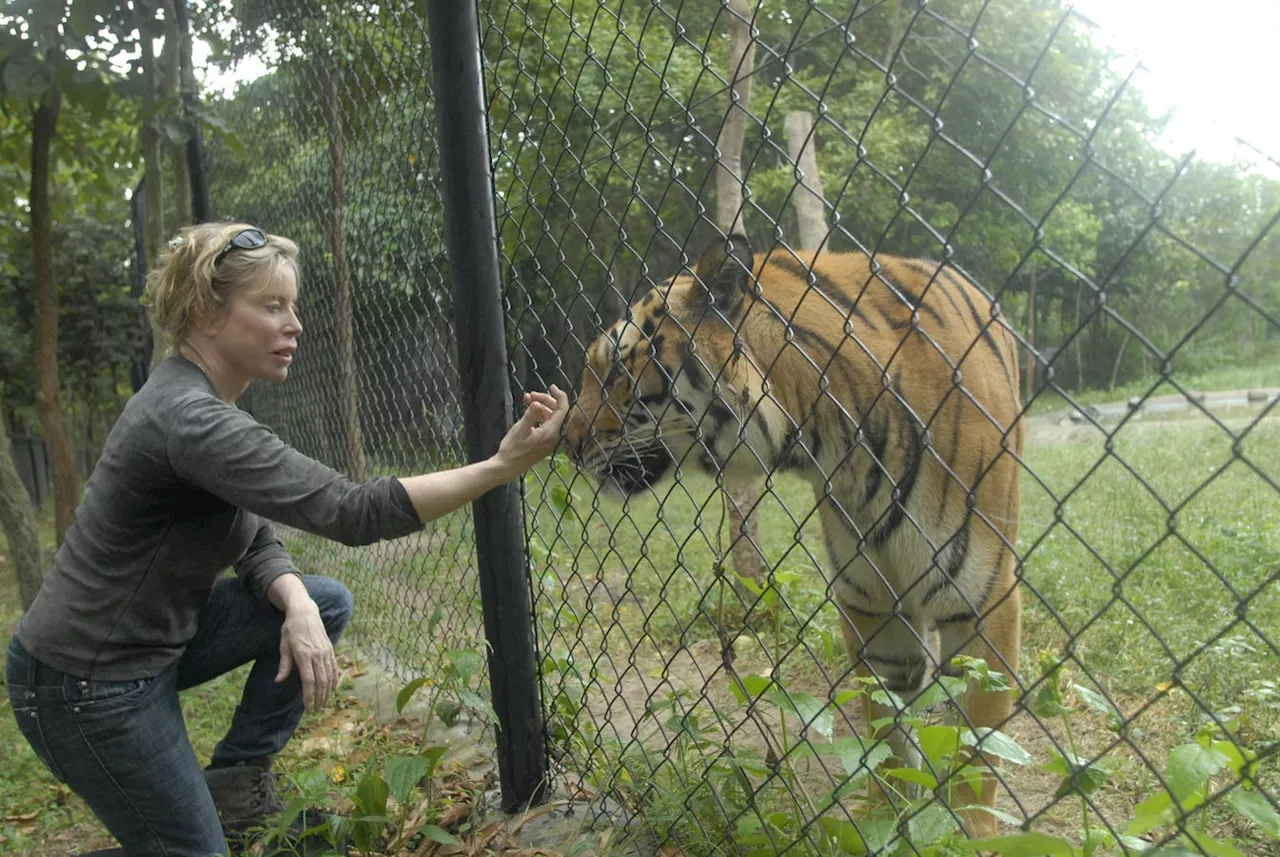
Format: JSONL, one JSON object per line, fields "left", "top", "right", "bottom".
{"left": 564, "top": 234, "right": 755, "bottom": 496}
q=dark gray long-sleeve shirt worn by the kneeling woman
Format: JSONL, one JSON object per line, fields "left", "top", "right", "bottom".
{"left": 17, "top": 357, "right": 422, "bottom": 680}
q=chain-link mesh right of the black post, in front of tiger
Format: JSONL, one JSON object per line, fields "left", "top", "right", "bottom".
{"left": 481, "top": 0, "right": 1280, "bottom": 854}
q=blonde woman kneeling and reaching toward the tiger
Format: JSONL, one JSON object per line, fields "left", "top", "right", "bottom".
{"left": 6, "top": 223, "right": 568, "bottom": 857}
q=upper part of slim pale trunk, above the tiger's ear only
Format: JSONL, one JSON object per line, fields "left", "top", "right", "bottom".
{"left": 716, "top": 0, "right": 755, "bottom": 234}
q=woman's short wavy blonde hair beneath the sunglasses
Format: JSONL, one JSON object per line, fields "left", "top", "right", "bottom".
{"left": 142, "top": 221, "right": 298, "bottom": 354}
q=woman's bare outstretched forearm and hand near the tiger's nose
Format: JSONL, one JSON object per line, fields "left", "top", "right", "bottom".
{"left": 401, "top": 384, "right": 568, "bottom": 523}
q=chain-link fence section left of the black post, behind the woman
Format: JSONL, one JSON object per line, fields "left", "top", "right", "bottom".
{"left": 210, "top": 1, "right": 489, "bottom": 728}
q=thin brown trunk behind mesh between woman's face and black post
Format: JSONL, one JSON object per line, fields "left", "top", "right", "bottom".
{"left": 324, "top": 69, "right": 367, "bottom": 481}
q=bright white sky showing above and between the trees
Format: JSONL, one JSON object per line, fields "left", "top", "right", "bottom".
{"left": 193, "top": 0, "right": 1280, "bottom": 161}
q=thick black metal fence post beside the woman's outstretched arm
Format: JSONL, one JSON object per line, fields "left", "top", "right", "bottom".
{"left": 426, "top": 0, "right": 547, "bottom": 812}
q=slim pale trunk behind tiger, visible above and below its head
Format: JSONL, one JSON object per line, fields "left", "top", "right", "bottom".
{"left": 716, "top": 0, "right": 767, "bottom": 596}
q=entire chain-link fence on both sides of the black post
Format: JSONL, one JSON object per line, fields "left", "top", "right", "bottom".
{"left": 204, "top": 0, "right": 1280, "bottom": 854}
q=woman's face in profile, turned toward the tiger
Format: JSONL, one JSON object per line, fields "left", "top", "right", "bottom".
{"left": 211, "top": 265, "right": 302, "bottom": 382}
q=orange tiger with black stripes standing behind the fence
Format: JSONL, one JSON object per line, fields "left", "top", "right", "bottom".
{"left": 564, "top": 233, "right": 1024, "bottom": 837}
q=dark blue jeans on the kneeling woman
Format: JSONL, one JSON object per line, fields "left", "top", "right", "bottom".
{"left": 6, "top": 574, "right": 352, "bottom": 857}
